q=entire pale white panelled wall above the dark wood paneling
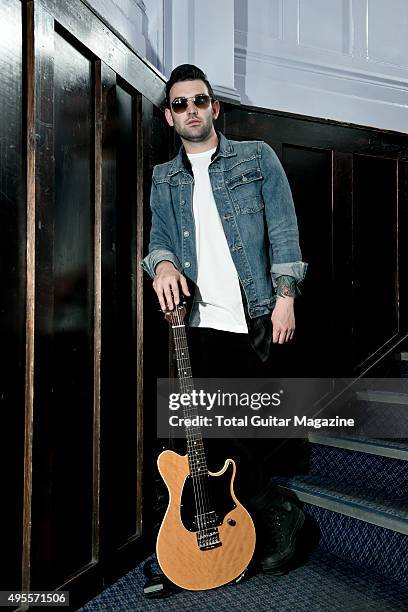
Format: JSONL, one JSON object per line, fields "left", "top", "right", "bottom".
{"left": 85, "top": 0, "right": 408, "bottom": 132}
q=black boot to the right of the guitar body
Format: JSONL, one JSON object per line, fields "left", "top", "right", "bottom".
{"left": 250, "top": 494, "right": 305, "bottom": 575}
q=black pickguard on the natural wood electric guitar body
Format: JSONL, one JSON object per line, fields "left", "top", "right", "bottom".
{"left": 180, "top": 463, "right": 236, "bottom": 531}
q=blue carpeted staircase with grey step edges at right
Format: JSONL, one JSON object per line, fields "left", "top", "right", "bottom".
{"left": 274, "top": 353, "right": 408, "bottom": 596}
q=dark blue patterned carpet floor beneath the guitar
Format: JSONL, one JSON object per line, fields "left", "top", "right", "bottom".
{"left": 81, "top": 549, "right": 408, "bottom": 612}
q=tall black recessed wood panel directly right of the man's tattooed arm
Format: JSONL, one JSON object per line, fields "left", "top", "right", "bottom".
{"left": 282, "top": 145, "right": 334, "bottom": 376}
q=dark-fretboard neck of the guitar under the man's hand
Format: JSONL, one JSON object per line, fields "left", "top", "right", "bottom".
{"left": 171, "top": 322, "right": 208, "bottom": 476}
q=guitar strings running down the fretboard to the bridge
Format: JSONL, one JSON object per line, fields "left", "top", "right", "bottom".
{"left": 173, "top": 309, "right": 211, "bottom": 530}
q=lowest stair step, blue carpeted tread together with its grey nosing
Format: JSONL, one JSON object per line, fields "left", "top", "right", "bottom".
{"left": 272, "top": 476, "right": 408, "bottom": 535}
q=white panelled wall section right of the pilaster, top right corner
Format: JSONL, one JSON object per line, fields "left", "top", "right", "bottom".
{"left": 235, "top": 0, "right": 408, "bottom": 132}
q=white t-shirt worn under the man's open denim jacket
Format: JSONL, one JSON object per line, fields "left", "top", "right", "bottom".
{"left": 188, "top": 148, "right": 248, "bottom": 333}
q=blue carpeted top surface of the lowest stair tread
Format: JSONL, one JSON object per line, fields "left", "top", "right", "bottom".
{"left": 273, "top": 475, "right": 408, "bottom": 525}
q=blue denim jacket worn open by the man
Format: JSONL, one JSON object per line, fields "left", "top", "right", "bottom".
{"left": 141, "top": 132, "right": 307, "bottom": 318}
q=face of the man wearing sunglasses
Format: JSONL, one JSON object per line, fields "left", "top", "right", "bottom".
{"left": 165, "top": 80, "right": 220, "bottom": 142}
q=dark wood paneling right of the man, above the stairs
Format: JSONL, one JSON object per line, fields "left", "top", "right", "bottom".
{"left": 223, "top": 104, "right": 408, "bottom": 376}
